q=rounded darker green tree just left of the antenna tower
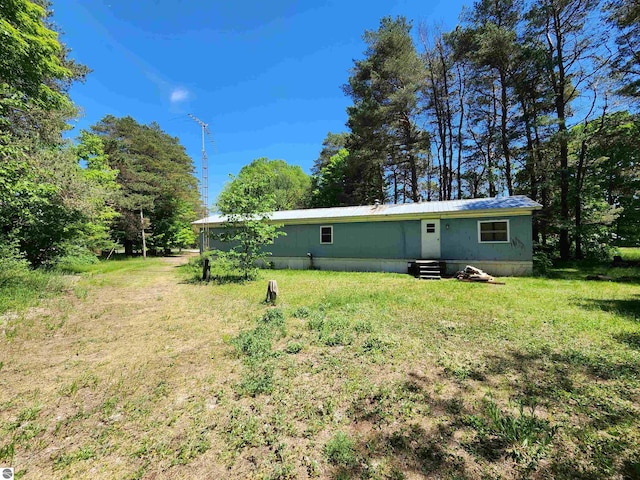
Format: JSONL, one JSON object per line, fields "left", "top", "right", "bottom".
{"left": 92, "top": 115, "right": 200, "bottom": 254}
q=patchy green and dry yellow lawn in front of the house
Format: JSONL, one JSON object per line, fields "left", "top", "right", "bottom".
{"left": 0, "top": 257, "right": 640, "bottom": 480}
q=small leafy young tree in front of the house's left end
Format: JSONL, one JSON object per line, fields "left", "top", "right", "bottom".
{"left": 218, "top": 178, "right": 284, "bottom": 280}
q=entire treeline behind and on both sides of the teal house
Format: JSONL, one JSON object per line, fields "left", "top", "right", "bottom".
{"left": 0, "top": 0, "right": 640, "bottom": 278}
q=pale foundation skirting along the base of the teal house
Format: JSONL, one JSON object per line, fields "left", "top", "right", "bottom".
{"left": 267, "top": 257, "right": 533, "bottom": 277}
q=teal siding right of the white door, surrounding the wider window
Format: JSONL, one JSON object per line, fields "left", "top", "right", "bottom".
{"left": 440, "top": 215, "right": 533, "bottom": 261}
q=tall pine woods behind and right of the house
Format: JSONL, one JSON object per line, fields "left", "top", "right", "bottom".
{"left": 307, "top": 0, "right": 640, "bottom": 259}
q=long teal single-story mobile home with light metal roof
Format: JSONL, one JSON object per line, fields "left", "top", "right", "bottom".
{"left": 194, "top": 196, "right": 542, "bottom": 275}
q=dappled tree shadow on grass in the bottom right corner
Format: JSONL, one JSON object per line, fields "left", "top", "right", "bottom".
{"left": 334, "top": 340, "right": 640, "bottom": 480}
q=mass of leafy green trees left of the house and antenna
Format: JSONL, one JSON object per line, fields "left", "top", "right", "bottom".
{"left": 0, "top": 0, "right": 201, "bottom": 283}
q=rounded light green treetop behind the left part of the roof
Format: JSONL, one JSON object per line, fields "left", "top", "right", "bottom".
{"left": 221, "top": 158, "right": 311, "bottom": 210}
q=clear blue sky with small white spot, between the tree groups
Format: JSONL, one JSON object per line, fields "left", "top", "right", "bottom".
{"left": 53, "top": 0, "right": 468, "bottom": 203}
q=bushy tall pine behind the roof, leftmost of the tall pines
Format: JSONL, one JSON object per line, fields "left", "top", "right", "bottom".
{"left": 344, "top": 17, "right": 429, "bottom": 203}
